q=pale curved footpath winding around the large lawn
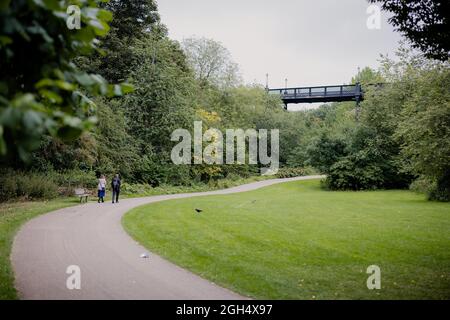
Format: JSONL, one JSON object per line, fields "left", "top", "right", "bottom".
{"left": 11, "top": 176, "right": 321, "bottom": 300}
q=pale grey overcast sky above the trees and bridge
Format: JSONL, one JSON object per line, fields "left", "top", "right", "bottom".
{"left": 158, "top": 0, "right": 400, "bottom": 88}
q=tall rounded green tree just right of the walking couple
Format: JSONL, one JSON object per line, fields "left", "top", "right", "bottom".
{"left": 121, "top": 34, "right": 195, "bottom": 186}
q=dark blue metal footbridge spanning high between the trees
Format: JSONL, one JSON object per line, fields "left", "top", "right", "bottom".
{"left": 267, "top": 83, "right": 364, "bottom": 109}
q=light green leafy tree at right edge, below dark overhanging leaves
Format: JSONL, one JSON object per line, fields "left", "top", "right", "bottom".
{"left": 395, "top": 65, "right": 450, "bottom": 201}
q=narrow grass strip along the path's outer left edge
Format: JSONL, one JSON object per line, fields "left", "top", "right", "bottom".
{"left": 0, "top": 198, "right": 79, "bottom": 300}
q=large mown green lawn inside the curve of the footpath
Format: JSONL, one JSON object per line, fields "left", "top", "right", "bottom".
{"left": 123, "top": 180, "right": 450, "bottom": 299}
